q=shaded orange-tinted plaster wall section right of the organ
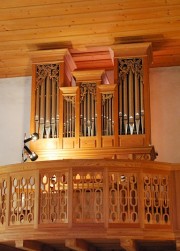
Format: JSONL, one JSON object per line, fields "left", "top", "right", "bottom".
{"left": 150, "top": 67, "right": 180, "bottom": 163}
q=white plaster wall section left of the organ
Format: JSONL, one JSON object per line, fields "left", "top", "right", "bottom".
{"left": 0, "top": 77, "right": 31, "bottom": 165}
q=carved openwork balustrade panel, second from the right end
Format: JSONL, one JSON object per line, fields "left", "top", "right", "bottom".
{"left": 108, "top": 172, "right": 139, "bottom": 223}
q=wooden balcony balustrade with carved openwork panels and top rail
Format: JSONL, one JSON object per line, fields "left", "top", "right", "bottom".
{"left": 0, "top": 160, "right": 178, "bottom": 235}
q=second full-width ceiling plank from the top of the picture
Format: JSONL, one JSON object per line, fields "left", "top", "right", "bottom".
{"left": 0, "top": 6, "right": 179, "bottom": 31}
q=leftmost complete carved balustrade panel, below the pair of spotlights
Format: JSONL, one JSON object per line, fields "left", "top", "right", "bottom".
{"left": 9, "top": 172, "right": 35, "bottom": 225}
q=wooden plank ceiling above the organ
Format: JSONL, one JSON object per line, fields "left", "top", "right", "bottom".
{"left": 0, "top": 0, "right": 180, "bottom": 78}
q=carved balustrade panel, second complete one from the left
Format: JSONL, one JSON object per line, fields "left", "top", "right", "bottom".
{"left": 39, "top": 171, "right": 68, "bottom": 223}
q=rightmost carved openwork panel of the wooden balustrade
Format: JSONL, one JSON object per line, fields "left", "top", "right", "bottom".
{"left": 144, "top": 174, "right": 170, "bottom": 224}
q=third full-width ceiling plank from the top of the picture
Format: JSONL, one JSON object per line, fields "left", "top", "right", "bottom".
{"left": 0, "top": 21, "right": 180, "bottom": 42}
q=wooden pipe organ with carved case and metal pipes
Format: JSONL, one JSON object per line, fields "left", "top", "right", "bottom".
{"left": 30, "top": 43, "right": 156, "bottom": 160}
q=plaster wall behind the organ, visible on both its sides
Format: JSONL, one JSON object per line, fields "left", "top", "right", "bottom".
{"left": 0, "top": 67, "right": 180, "bottom": 165}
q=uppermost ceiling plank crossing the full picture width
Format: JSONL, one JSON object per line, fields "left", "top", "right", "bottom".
{"left": 0, "top": 0, "right": 178, "bottom": 20}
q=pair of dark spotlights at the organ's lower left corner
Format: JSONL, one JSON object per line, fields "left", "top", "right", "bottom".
{"left": 22, "top": 132, "right": 39, "bottom": 162}
